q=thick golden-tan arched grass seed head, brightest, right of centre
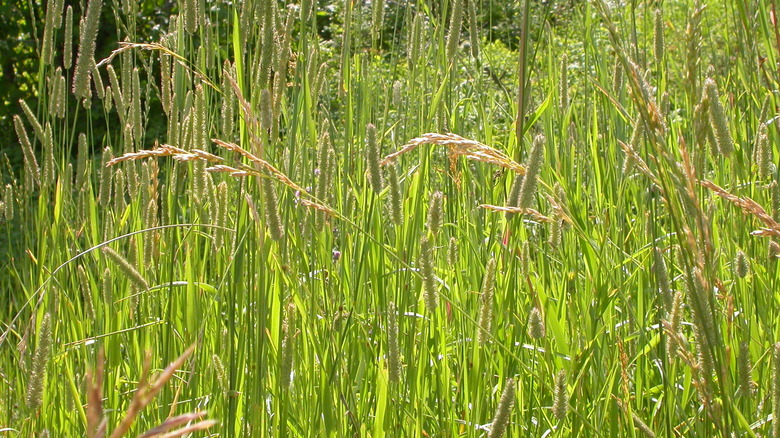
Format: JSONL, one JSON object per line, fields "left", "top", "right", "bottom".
{"left": 379, "top": 133, "right": 526, "bottom": 175}
